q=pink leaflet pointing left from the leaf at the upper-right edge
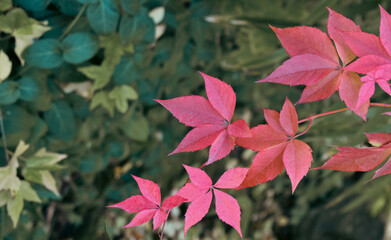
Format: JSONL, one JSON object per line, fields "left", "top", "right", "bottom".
{"left": 338, "top": 30, "right": 390, "bottom": 58}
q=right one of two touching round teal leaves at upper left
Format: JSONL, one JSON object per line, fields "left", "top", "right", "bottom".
{"left": 62, "top": 32, "right": 99, "bottom": 64}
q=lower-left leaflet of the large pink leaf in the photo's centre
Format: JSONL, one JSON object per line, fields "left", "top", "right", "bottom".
{"left": 169, "top": 125, "right": 225, "bottom": 155}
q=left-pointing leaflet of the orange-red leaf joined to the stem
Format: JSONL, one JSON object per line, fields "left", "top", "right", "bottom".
{"left": 236, "top": 124, "right": 289, "bottom": 151}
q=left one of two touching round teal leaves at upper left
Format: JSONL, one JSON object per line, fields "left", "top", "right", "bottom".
{"left": 23, "top": 39, "right": 63, "bottom": 68}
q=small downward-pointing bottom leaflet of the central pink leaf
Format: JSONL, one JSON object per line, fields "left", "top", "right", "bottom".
{"left": 206, "top": 131, "right": 235, "bottom": 165}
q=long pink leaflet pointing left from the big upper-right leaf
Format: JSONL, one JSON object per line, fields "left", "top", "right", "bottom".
{"left": 257, "top": 54, "right": 338, "bottom": 86}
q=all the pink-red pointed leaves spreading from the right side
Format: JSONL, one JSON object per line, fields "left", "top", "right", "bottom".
{"left": 110, "top": 7, "right": 391, "bottom": 236}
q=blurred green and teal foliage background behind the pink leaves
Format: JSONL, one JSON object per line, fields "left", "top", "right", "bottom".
{"left": 0, "top": 0, "right": 391, "bottom": 240}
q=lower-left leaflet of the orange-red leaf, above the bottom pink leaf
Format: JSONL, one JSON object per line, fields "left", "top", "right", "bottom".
{"left": 238, "top": 143, "right": 287, "bottom": 189}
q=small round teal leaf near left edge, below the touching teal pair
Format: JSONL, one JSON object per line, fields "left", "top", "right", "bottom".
{"left": 19, "top": 76, "right": 43, "bottom": 101}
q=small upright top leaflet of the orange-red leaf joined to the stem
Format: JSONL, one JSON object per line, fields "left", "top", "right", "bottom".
{"left": 280, "top": 98, "right": 299, "bottom": 136}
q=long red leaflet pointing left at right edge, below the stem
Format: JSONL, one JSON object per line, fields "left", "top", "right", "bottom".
{"left": 317, "top": 147, "right": 391, "bottom": 172}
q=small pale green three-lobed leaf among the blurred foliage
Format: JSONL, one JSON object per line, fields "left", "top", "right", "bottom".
{"left": 109, "top": 85, "right": 138, "bottom": 113}
